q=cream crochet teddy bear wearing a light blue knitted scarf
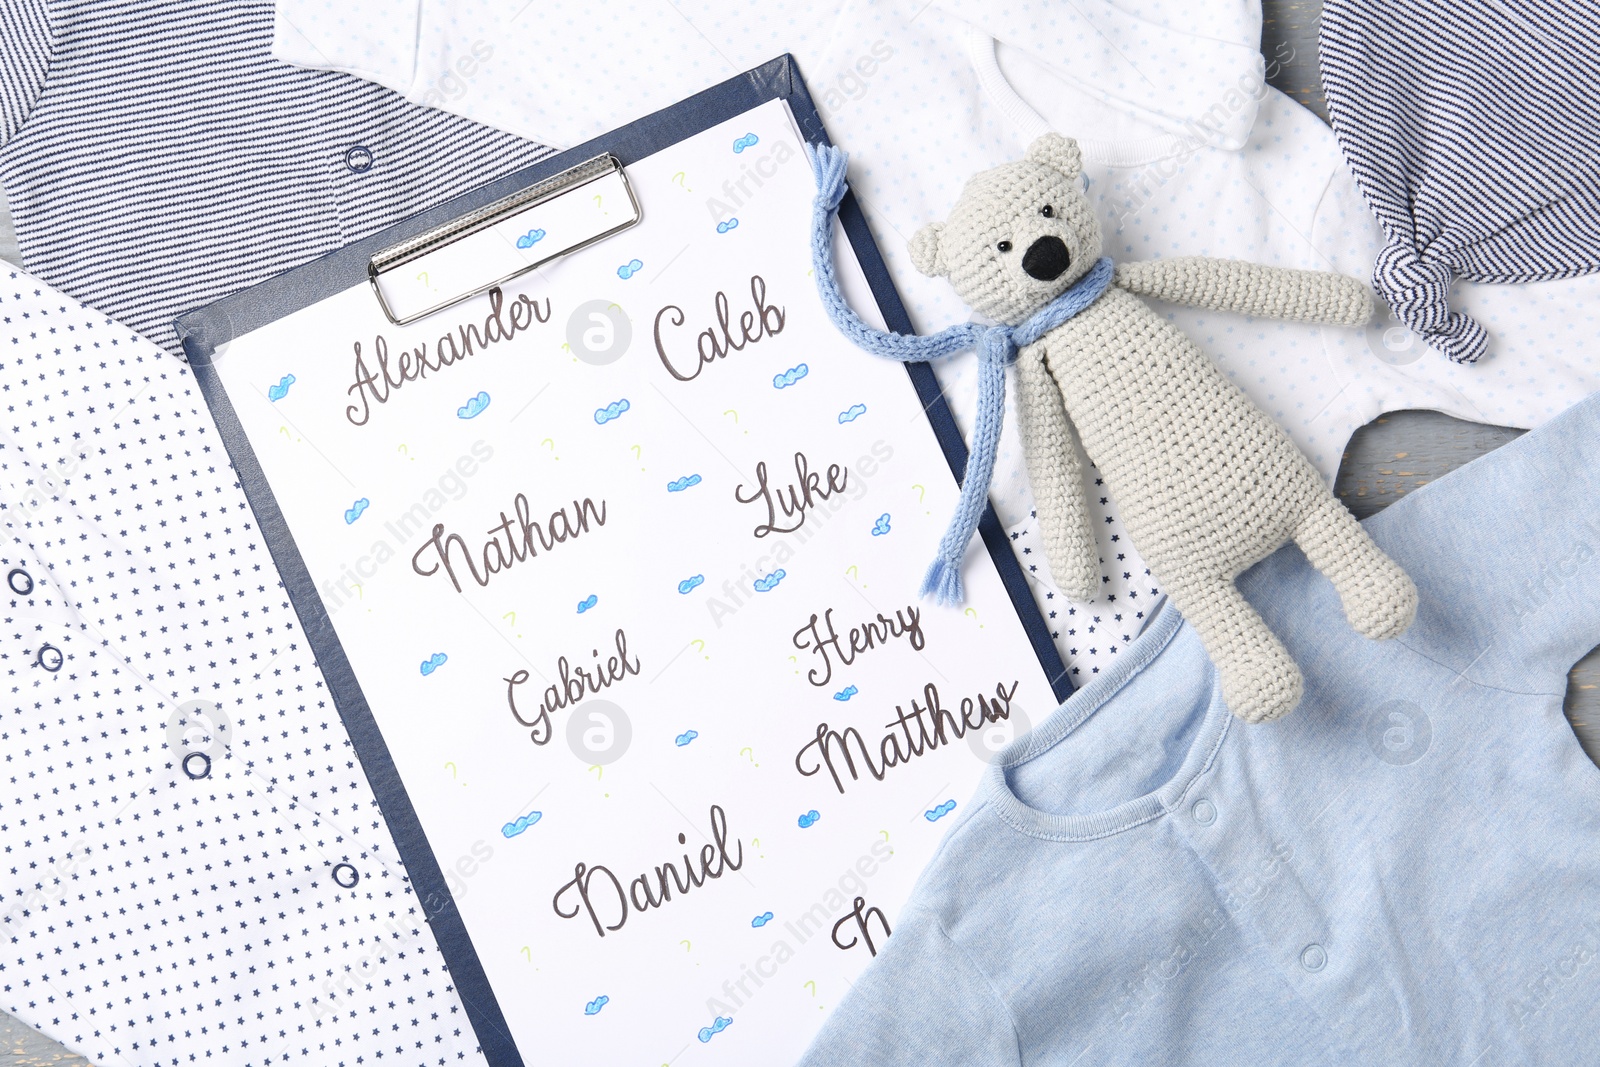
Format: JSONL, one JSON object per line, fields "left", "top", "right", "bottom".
{"left": 810, "top": 133, "right": 1416, "bottom": 723}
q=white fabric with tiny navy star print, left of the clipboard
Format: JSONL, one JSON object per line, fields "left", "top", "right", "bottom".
{"left": 0, "top": 272, "right": 483, "bottom": 1067}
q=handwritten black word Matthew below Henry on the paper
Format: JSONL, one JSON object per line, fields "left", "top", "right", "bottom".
{"left": 795, "top": 681, "right": 1021, "bottom": 792}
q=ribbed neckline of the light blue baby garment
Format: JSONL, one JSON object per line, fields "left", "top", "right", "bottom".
{"left": 984, "top": 603, "right": 1232, "bottom": 841}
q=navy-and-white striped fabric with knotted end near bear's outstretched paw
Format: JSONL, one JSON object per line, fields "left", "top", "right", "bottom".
{"left": 1320, "top": 0, "right": 1600, "bottom": 363}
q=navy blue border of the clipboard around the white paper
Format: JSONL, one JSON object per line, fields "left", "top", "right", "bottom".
{"left": 176, "top": 54, "right": 1072, "bottom": 1067}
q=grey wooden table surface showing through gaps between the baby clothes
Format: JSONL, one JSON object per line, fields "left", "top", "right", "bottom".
{"left": 0, "top": 0, "right": 1600, "bottom": 1067}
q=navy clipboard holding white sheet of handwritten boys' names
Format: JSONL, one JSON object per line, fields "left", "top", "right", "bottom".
{"left": 176, "top": 56, "right": 1072, "bottom": 1067}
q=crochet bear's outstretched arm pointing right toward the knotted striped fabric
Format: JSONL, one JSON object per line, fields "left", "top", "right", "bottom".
{"left": 1117, "top": 256, "right": 1373, "bottom": 326}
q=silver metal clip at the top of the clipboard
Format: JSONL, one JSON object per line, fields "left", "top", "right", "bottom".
{"left": 366, "top": 152, "right": 643, "bottom": 326}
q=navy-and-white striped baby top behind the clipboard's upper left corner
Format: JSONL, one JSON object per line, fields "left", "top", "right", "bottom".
{"left": 0, "top": 0, "right": 549, "bottom": 352}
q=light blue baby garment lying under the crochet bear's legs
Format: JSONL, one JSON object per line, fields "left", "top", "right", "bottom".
{"left": 803, "top": 397, "right": 1600, "bottom": 1067}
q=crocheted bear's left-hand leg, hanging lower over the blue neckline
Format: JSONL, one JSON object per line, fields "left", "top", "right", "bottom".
{"left": 1166, "top": 577, "right": 1306, "bottom": 723}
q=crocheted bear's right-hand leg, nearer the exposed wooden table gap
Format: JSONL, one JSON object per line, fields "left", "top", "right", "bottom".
{"left": 1294, "top": 496, "right": 1416, "bottom": 640}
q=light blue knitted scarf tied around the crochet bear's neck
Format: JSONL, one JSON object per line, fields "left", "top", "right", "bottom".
{"left": 805, "top": 144, "right": 1112, "bottom": 605}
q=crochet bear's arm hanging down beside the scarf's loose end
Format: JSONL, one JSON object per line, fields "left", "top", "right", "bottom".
{"left": 1016, "top": 342, "right": 1101, "bottom": 600}
